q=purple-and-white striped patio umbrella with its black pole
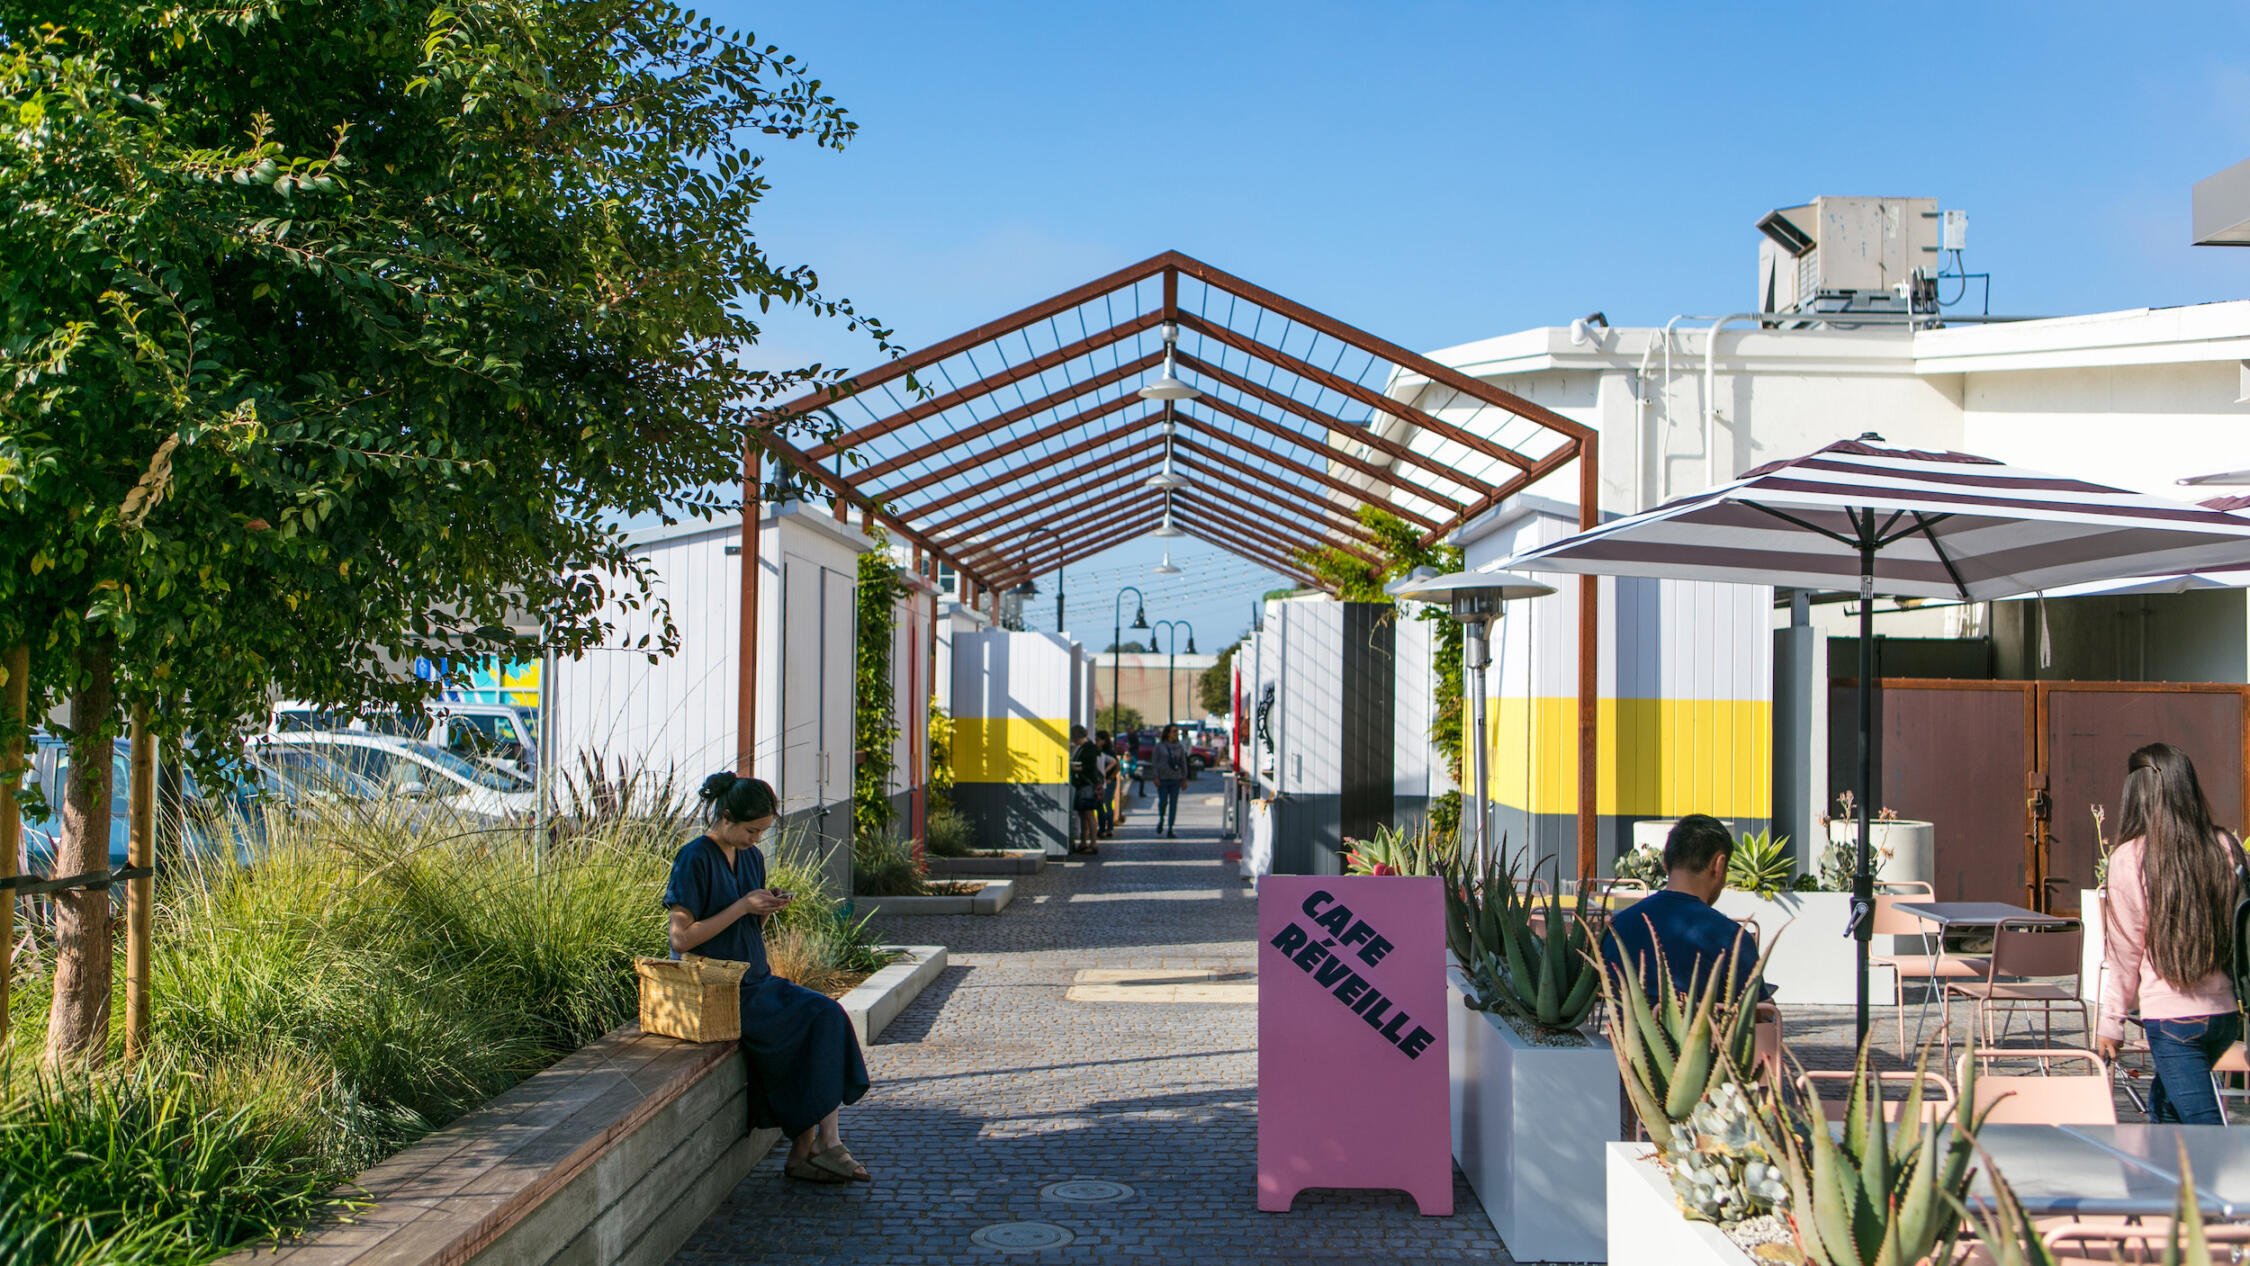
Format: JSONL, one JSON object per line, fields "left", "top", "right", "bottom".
{"left": 1501, "top": 434, "right": 2250, "bottom": 1039}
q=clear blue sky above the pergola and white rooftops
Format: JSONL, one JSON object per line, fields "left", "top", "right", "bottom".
{"left": 704, "top": 0, "right": 2250, "bottom": 650}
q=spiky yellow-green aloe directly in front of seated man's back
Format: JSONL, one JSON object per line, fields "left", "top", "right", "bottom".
{"left": 1595, "top": 942, "right": 1766, "bottom": 1156}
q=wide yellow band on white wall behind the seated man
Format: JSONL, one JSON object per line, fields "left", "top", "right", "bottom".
{"left": 1485, "top": 697, "right": 1773, "bottom": 819}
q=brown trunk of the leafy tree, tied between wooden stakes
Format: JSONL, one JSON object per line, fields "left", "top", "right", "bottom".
{"left": 47, "top": 643, "right": 115, "bottom": 1064}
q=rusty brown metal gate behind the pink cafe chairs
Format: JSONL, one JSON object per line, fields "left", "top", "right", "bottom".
{"left": 1829, "top": 677, "right": 2250, "bottom": 913}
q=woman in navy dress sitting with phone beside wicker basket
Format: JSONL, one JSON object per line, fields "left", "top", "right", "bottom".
{"left": 664, "top": 771, "right": 869, "bottom": 1183}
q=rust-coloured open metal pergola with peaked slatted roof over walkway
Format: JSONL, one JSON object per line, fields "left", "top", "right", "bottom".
{"left": 740, "top": 252, "right": 1598, "bottom": 870}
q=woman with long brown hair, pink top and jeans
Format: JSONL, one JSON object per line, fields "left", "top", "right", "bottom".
{"left": 2097, "top": 742, "right": 2241, "bottom": 1124}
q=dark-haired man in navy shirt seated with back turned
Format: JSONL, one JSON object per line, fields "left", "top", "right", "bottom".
{"left": 1602, "top": 814, "right": 1773, "bottom": 1005}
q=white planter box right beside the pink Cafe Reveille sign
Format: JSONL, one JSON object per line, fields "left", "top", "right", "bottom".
{"left": 1445, "top": 967, "right": 1620, "bottom": 1262}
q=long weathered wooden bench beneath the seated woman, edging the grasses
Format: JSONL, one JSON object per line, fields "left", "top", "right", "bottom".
{"left": 227, "top": 1025, "right": 781, "bottom": 1266}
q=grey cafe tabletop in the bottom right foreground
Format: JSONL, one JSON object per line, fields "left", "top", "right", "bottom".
{"left": 1971, "top": 1124, "right": 2250, "bottom": 1221}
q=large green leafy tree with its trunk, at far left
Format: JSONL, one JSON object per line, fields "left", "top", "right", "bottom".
{"left": 0, "top": 0, "right": 889, "bottom": 1059}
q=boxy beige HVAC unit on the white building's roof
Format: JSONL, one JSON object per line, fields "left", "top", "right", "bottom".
{"left": 1757, "top": 198, "right": 1940, "bottom": 313}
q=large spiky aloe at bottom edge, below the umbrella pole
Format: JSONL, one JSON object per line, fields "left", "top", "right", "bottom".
{"left": 1778, "top": 1043, "right": 1989, "bottom": 1266}
